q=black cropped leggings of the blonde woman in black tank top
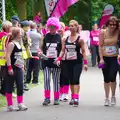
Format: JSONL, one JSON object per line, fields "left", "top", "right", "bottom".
{"left": 66, "top": 60, "right": 83, "bottom": 85}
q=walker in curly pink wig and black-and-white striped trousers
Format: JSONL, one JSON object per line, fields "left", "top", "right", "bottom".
{"left": 42, "top": 17, "right": 61, "bottom": 105}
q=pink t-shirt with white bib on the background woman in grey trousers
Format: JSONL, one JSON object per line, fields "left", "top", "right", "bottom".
{"left": 90, "top": 30, "right": 100, "bottom": 46}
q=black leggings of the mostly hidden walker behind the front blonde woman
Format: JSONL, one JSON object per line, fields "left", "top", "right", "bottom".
{"left": 60, "top": 61, "right": 69, "bottom": 87}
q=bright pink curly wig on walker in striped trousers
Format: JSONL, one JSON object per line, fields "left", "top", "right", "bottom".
{"left": 46, "top": 17, "right": 60, "bottom": 30}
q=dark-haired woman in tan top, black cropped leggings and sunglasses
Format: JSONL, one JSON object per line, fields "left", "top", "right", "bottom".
{"left": 99, "top": 16, "right": 119, "bottom": 106}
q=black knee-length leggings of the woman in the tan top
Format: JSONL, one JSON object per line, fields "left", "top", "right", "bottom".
{"left": 102, "top": 57, "right": 118, "bottom": 83}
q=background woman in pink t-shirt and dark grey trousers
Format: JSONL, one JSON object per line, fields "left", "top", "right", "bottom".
{"left": 90, "top": 24, "right": 100, "bottom": 67}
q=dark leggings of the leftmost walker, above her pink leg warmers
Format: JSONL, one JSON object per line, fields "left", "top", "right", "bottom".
{"left": 5, "top": 67, "right": 24, "bottom": 96}
